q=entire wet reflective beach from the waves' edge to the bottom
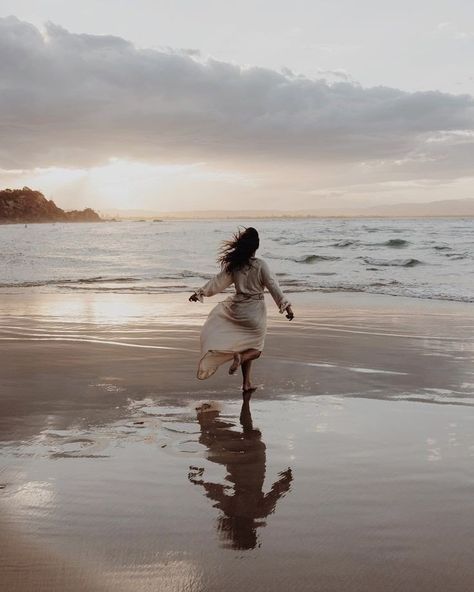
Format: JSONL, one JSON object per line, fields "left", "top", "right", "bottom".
{"left": 0, "top": 293, "right": 474, "bottom": 592}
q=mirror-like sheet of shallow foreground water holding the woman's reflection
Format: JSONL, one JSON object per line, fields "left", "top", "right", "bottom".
{"left": 1, "top": 393, "right": 474, "bottom": 592}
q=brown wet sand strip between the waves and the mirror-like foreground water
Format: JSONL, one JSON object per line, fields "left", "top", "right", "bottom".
{"left": 0, "top": 293, "right": 474, "bottom": 441}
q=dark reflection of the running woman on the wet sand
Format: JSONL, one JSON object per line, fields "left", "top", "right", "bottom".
{"left": 188, "top": 401, "right": 293, "bottom": 549}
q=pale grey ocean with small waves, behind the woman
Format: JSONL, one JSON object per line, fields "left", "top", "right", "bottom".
{"left": 0, "top": 218, "right": 474, "bottom": 302}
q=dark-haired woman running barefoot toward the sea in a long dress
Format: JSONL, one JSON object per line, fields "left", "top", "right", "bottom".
{"left": 189, "top": 228, "right": 294, "bottom": 395}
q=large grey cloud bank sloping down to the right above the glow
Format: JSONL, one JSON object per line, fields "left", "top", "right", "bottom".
{"left": 0, "top": 17, "right": 474, "bottom": 176}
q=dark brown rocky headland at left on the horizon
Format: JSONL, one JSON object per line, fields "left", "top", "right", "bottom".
{"left": 0, "top": 187, "right": 102, "bottom": 224}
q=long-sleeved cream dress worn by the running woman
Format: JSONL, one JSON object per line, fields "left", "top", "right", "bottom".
{"left": 196, "top": 257, "right": 290, "bottom": 380}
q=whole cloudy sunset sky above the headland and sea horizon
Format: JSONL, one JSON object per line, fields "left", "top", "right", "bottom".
{"left": 0, "top": 0, "right": 474, "bottom": 213}
